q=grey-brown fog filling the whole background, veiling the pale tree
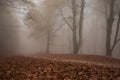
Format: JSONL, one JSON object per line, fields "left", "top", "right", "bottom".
{"left": 0, "top": 0, "right": 120, "bottom": 59}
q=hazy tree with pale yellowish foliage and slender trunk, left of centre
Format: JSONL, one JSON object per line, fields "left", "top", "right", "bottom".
{"left": 24, "top": 0, "right": 60, "bottom": 54}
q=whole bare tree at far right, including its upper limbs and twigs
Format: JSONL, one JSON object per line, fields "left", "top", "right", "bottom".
{"left": 91, "top": 0, "right": 120, "bottom": 56}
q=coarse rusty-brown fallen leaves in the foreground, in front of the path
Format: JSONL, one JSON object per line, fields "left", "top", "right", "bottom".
{"left": 0, "top": 56, "right": 120, "bottom": 80}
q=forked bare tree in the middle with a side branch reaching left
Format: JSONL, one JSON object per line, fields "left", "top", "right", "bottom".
{"left": 60, "top": 0, "right": 85, "bottom": 54}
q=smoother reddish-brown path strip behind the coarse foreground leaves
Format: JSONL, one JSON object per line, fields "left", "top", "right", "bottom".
{"left": 31, "top": 54, "right": 120, "bottom": 67}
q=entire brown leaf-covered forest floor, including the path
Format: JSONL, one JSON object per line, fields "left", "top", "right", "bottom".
{"left": 0, "top": 54, "right": 120, "bottom": 80}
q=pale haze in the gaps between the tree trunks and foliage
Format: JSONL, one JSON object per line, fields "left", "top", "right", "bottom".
{"left": 0, "top": 0, "right": 120, "bottom": 59}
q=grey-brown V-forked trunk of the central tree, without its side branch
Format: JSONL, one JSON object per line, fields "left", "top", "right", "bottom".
{"left": 72, "top": 0, "right": 85, "bottom": 54}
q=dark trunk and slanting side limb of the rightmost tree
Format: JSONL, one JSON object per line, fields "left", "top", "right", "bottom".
{"left": 106, "top": 0, "right": 120, "bottom": 56}
